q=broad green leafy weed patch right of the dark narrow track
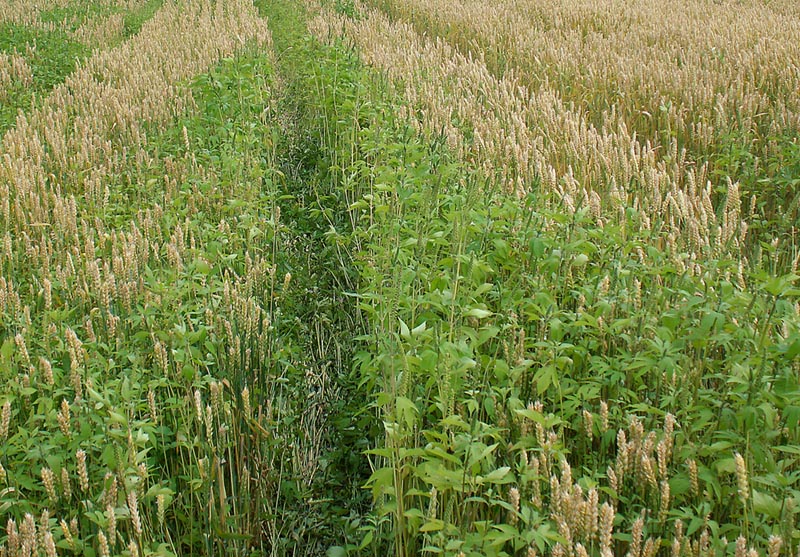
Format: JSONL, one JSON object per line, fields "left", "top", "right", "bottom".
{"left": 282, "top": 9, "right": 800, "bottom": 555}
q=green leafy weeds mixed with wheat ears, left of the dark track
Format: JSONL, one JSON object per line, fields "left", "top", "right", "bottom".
{"left": 0, "top": 39, "right": 372, "bottom": 555}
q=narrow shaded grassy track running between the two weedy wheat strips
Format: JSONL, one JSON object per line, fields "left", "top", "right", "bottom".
{"left": 256, "top": 0, "right": 390, "bottom": 554}
